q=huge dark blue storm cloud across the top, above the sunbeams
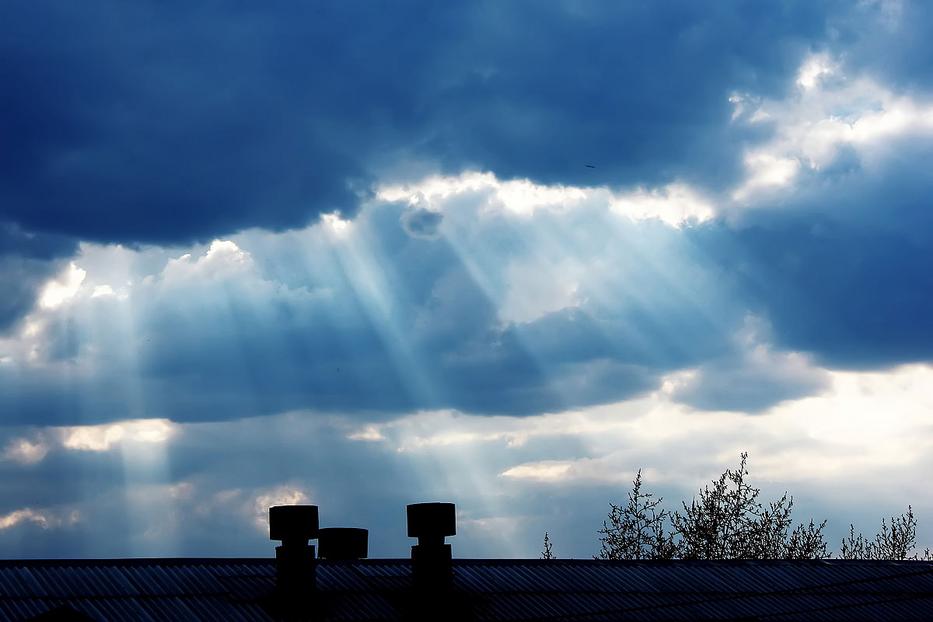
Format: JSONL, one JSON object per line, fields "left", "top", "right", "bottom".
{"left": 0, "top": 0, "right": 828, "bottom": 243}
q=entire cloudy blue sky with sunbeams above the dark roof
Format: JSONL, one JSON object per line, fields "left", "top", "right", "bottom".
{"left": 0, "top": 0, "right": 933, "bottom": 558}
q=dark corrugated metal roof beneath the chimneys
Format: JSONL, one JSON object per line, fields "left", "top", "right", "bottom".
{"left": 0, "top": 559, "right": 933, "bottom": 621}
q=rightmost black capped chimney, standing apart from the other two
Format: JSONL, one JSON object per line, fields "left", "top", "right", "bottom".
{"left": 408, "top": 503, "right": 457, "bottom": 583}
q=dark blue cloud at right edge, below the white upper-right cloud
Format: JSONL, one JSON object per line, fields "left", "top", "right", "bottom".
{"left": 690, "top": 137, "right": 933, "bottom": 368}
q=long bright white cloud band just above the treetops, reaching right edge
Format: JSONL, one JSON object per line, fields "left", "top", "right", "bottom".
{"left": 354, "top": 364, "right": 933, "bottom": 503}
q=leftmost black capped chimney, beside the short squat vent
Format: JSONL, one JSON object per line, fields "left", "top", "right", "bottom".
{"left": 269, "top": 505, "right": 318, "bottom": 597}
